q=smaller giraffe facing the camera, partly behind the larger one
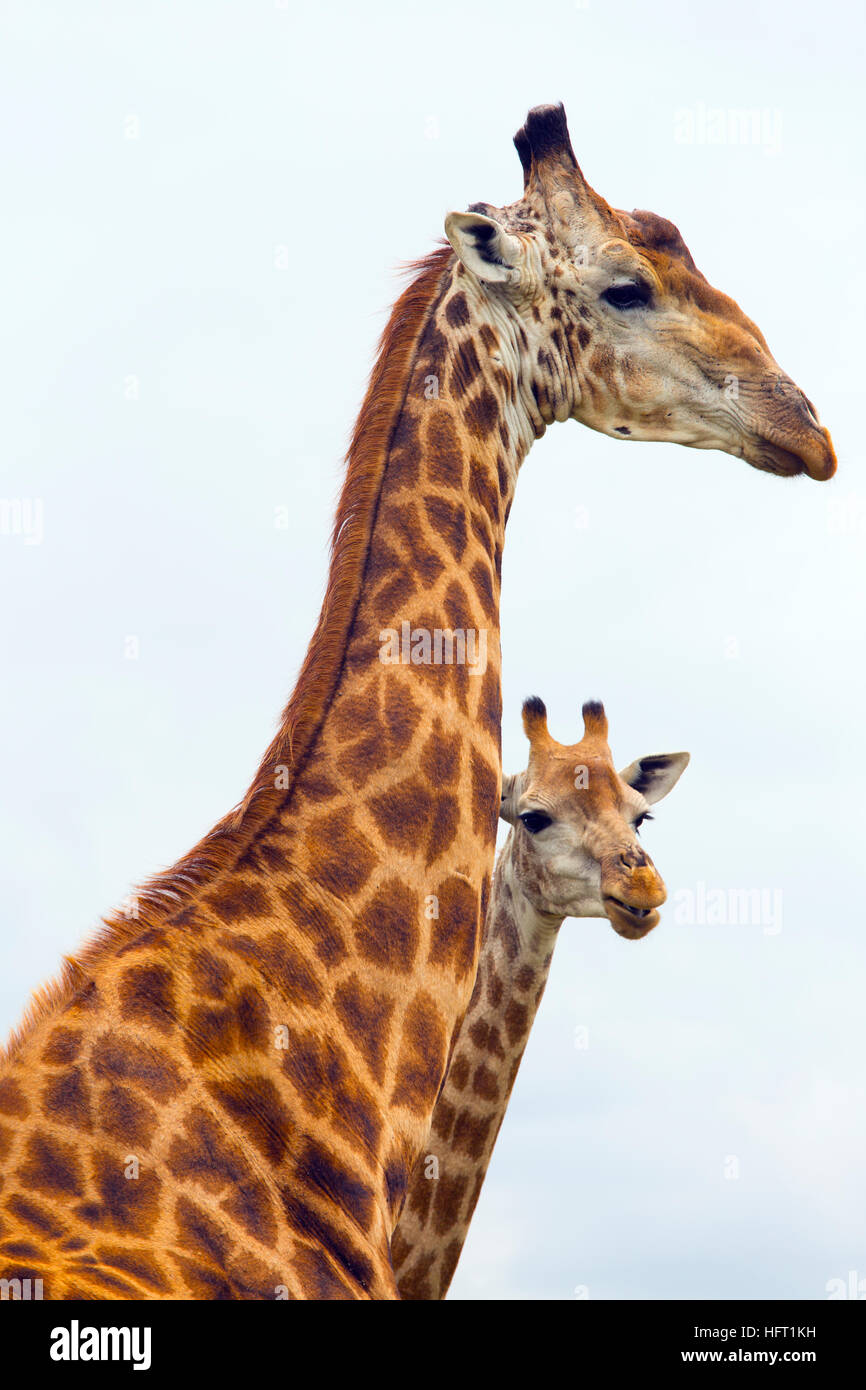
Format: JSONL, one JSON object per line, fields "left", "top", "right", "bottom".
{"left": 391, "top": 698, "right": 688, "bottom": 1298}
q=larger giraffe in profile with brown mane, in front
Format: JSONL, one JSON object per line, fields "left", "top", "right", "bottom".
{"left": 0, "top": 107, "right": 835, "bottom": 1298}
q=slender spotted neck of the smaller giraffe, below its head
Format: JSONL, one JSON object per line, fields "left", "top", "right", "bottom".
{"left": 392, "top": 831, "right": 563, "bottom": 1300}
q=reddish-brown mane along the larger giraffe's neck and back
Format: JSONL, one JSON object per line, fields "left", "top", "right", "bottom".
{"left": 0, "top": 243, "right": 453, "bottom": 1062}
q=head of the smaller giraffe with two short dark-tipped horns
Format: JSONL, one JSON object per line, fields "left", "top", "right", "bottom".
{"left": 500, "top": 696, "right": 689, "bottom": 940}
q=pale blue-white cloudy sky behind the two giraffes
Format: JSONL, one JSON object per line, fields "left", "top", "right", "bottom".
{"left": 0, "top": 0, "right": 866, "bottom": 1300}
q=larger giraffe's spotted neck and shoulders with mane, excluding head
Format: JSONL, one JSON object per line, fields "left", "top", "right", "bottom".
{"left": 0, "top": 253, "right": 541, "bottom": 1297}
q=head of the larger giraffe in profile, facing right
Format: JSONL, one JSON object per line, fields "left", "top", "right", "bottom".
{"left": 445, "top": 106, "right": 835, "bottom": 480}
